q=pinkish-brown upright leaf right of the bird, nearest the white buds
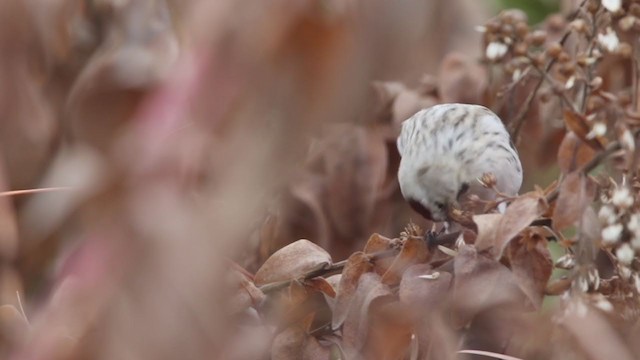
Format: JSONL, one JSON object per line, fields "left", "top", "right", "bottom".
{"left": 552, "top": 172, "right": 595, "bottom": 230}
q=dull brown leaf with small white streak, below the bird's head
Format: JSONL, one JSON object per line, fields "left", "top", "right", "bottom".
{"left": 398, "top": 264, "right": 453, "bottom": 316}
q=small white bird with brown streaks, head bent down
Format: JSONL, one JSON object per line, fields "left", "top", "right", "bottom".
{"left": 398, "top": 104, "right": 522, "bottom": 221}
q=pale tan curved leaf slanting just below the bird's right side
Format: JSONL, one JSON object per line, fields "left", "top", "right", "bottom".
{"left": 491, "top": 193, "right": 548, "bottom": 259}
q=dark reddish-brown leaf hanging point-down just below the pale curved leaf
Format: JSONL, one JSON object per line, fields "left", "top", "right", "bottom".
{"left": 506, "top": 232, "right": 553, "bottom": 310}
